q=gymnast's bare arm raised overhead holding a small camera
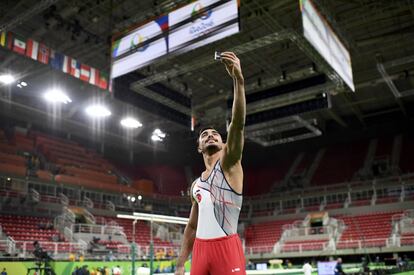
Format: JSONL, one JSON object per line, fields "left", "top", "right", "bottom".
{"left": 221, "top": 52, "right": 246, "bottom": 167}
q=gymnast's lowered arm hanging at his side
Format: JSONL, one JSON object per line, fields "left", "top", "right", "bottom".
{"left": 175, "top": 182, "right": 198, "bottom": 275}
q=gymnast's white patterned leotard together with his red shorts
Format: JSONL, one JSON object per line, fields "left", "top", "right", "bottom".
{"left": 191, "top": 161, "right": 246, "bottom": 275}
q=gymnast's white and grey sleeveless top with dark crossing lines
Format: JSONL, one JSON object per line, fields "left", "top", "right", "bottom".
{"left": 192, "top": 161, "right": 243, "bottom": 239}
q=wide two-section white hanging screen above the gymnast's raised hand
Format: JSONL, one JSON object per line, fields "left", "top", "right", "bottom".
{"left": 111, "top": 0, "right": 240, "bottom": 78}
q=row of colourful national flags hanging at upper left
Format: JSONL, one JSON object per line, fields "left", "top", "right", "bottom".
{"left": 0, "top": 32, "right": 109, "bottom": 90}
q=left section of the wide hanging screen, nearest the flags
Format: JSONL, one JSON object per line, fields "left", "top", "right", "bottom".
{"left": 111, "top": 18, "right": 168, "bottom": 78}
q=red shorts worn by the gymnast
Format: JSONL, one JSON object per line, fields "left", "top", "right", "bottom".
{"left": 190, "top": 234, "right": 246, "bottom": 275}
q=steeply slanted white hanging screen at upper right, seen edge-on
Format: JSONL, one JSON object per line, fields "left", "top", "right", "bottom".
{"left": 300, "top": 0, "right": 355, "bottom": 91}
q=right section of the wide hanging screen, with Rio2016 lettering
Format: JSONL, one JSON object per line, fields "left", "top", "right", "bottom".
{"left": 168, "top": 0, "right": 240, "bottom": 52}
